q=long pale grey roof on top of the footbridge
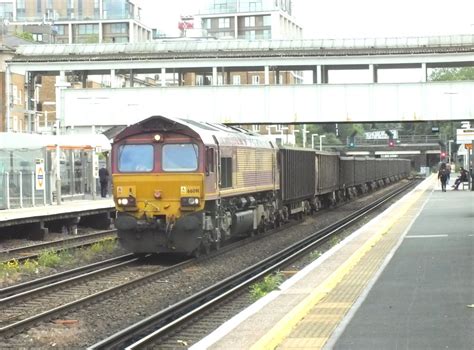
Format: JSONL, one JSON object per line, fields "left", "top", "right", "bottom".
{"left": 12, "top": 34, "right": 474, "bottom": 62}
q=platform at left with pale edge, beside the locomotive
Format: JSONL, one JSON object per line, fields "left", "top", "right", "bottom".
{"left": 0, "top": 198, "right": 115, "bottom": 239}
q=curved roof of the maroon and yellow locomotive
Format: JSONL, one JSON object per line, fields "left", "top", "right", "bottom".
{"left": 114, "top": 116, "right": 276, "bottom": 148}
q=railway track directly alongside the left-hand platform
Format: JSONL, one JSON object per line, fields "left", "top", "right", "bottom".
{"left": 0, "top": 229, "right": 117, "bottom": 264}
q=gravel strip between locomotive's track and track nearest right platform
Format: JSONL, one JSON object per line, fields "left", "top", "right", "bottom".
{"left": 0, "top": 181, "right": 412, "bottom": 349}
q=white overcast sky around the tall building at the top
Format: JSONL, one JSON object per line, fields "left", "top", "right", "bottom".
{"left": 139, "top": 0, "right": 474, "bottom": 38}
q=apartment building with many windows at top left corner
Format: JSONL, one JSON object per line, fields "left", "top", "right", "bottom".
{"left": 0, "top": 0, "right": 152, "bottom": 44}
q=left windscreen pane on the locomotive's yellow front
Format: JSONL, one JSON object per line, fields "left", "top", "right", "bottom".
{"left": 118, "top": 145, "right": 154, "bottom": 173}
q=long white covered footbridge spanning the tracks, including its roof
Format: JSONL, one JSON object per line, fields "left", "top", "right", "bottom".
{"left": 6, "top": 35, "right": 474, "bottom": 126}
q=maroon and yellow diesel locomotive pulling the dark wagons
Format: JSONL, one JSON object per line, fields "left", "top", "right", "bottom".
{"left": 112, "top": 116, "right": 284, "bottom": 254}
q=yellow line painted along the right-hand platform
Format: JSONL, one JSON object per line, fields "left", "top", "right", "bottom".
{"left": 250, "top": 176, "right": 436, "bottom": 350}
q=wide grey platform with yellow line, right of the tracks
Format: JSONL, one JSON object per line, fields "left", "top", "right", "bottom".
{"left": 191, "top": 175, "right": 474, "bottom": 349}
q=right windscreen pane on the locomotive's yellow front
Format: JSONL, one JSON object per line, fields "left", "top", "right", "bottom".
{"left": 162, "top": 143, "right": 198, "bottom": 171}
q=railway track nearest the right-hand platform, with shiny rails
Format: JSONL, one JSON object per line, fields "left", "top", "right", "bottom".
{"left": 88, "top": 179, "right": 413, "bottom": 350}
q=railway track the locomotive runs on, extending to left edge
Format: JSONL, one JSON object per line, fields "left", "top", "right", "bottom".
{"left": 0, "top": 208, "right": 296, "bottom": 337}
